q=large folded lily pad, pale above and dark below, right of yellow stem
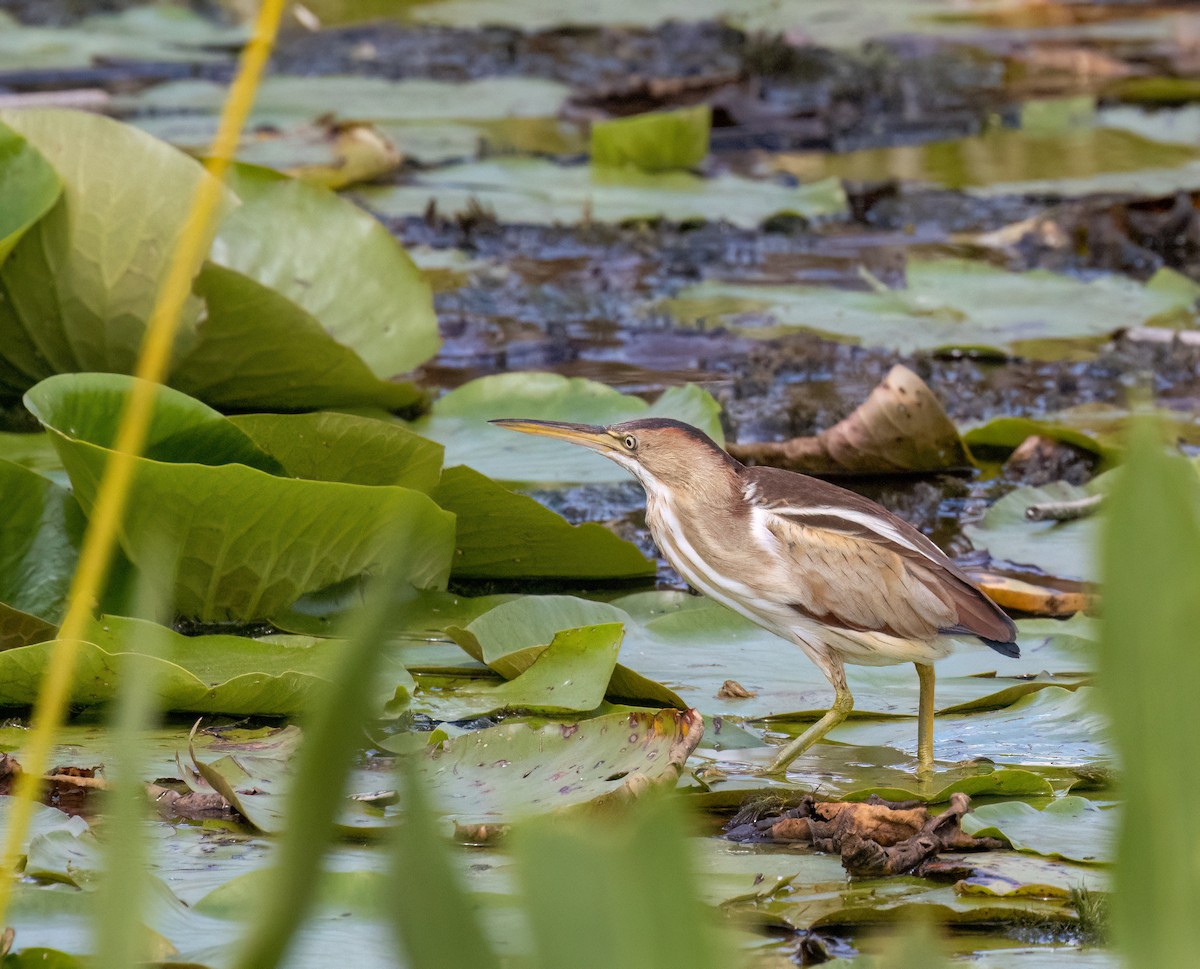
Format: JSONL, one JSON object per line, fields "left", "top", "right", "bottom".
{"left": 173, "top": 165, "right": 440, "bottom": 409}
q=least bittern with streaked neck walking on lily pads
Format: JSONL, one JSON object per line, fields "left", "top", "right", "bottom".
{"left": 492, "top": 419, "right": 1020, "bottom": 772}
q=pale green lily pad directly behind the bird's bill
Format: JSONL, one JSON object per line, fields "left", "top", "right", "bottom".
{"left": 412, "top": 373, "right": 724, "bottom": 483}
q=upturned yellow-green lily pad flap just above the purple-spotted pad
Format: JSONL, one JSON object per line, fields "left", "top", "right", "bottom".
{"left": 416, "top": 622, "right": 624, "bottom": 720}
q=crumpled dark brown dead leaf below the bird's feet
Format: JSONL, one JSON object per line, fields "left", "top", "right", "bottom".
{"left": 726, "top": 793, "right": 1004, "bottom": 875}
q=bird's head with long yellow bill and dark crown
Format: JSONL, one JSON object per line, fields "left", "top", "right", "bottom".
{"left": 491, "top": 417, "right": 737, "bottom": 489}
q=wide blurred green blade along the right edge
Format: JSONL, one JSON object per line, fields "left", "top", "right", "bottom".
{"left": 1100, "top": 420, "right": 1200, "bottom": 969}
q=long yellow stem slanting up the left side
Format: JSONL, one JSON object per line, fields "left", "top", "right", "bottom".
{"left": 0, "top": 0, "right": 284, "bottom": 926}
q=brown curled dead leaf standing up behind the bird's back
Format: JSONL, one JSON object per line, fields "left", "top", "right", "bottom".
{"left": 728, "top": 363, "right": 971, "bottom": 475}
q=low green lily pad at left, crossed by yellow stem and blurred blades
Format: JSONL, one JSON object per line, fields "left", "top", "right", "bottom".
{"left": 0, "top": 616, "right": 415, "bottom": 716}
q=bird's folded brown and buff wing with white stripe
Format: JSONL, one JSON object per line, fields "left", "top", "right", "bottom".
{"left": 745, "top": 468, "right": 1016, "bottom": 655}
